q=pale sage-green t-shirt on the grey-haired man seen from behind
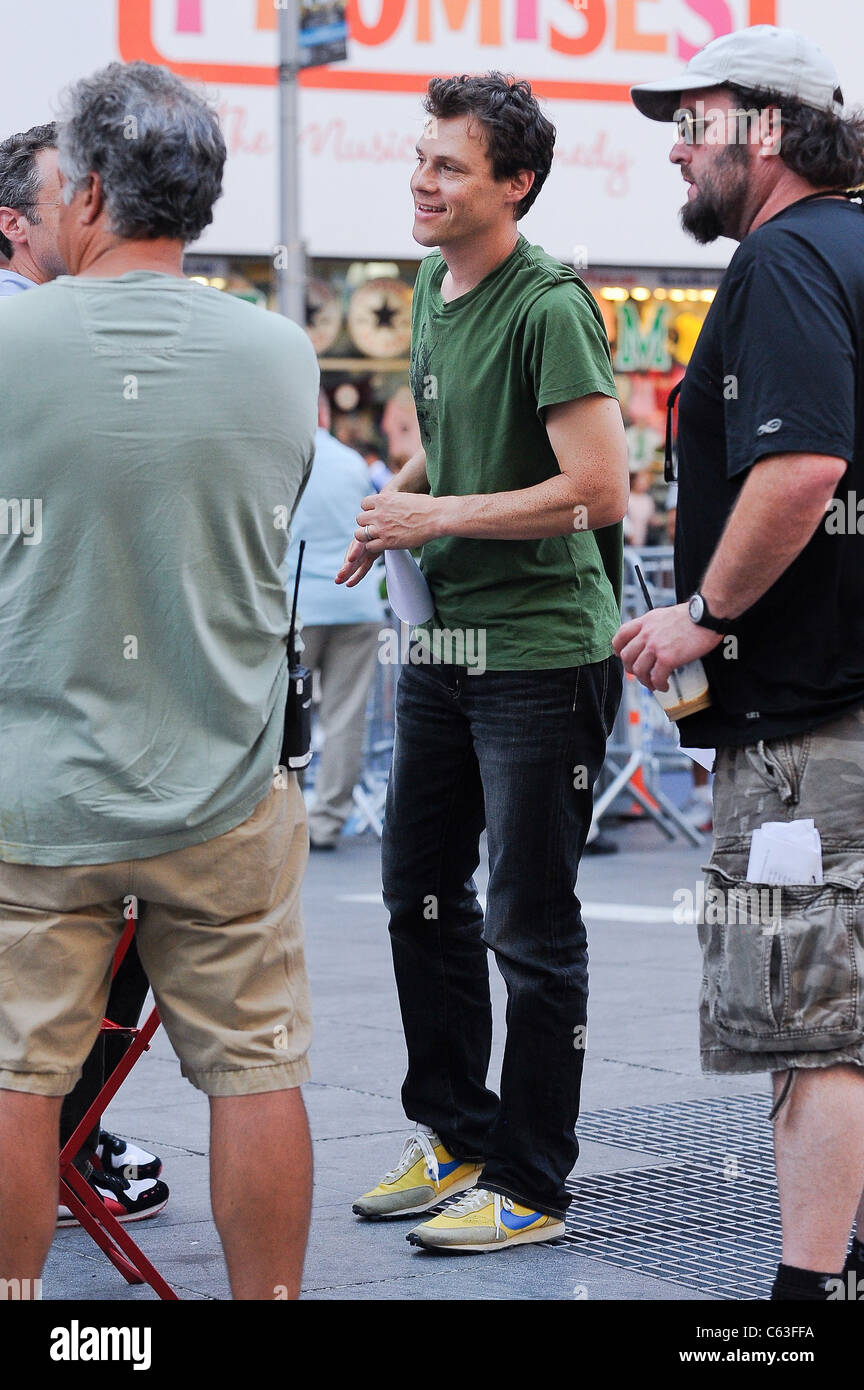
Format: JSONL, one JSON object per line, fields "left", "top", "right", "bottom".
{"left": 0, "top": 271, "right": 318, "bottom": 865}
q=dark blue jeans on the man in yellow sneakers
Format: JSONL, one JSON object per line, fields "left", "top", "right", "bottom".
{"left": 382, "top": 657, "right": 622, "bottom": 1216}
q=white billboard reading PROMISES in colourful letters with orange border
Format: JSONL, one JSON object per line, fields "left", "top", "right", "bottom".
{"left": 0, "top": 0, "right": 864, "bottom": 268}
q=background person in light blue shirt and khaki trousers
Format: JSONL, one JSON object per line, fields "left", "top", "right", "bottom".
{"left": 286, "top": 391, "right": 383, "bottom": 849}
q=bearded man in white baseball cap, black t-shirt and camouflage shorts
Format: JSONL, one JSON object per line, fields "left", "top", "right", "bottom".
{"left": 615, "top": 25, "right": 864, "bottom": 1301}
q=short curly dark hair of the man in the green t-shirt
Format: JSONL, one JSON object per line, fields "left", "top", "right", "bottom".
{"left": 424, "top": 72, "right": 556, "bottom": 221}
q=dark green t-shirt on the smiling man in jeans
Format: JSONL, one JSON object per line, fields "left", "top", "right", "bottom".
{"left": 411, "top": 236, "right": 622, "bottom": 670}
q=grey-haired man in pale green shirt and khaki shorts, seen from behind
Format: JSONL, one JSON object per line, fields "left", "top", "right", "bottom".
{"left": 0, "top": 63, "right": 318, "bottom": 1298}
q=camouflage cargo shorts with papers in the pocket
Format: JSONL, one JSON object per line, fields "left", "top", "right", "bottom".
{"left": 699, "top": 709, "right": 864, "bottom": 1073}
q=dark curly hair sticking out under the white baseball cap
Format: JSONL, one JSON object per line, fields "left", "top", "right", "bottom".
{"left": 726, "top": 85, "right": 864, "bottom": 189}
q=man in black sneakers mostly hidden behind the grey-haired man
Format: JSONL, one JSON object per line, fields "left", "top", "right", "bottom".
{"left": 0, "top": 122, "right": 169, "bottom": 1226}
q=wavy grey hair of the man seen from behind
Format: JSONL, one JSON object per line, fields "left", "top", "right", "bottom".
{"left": 60, "top": 63, "right": 225, "bottom": 243}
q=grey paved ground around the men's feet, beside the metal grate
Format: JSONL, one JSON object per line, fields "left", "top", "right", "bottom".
{"left": 44, "top": 826, "right": 767, "bottom": 1301}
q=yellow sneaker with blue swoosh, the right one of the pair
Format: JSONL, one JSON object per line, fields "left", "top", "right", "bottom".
{"left": 406, "top": 1187, "right": 564, "bottom": 1254}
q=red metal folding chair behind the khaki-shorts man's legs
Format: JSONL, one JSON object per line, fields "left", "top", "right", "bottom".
{"left": 60, "top": 905, "right": 178, "bottom": 1298}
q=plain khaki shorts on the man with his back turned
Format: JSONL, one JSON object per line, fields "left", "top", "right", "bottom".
{"left": 0, "top": 774, "right": 311, "bottom": 1095}
